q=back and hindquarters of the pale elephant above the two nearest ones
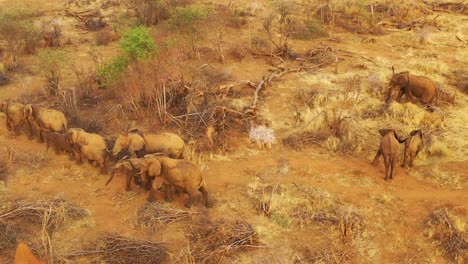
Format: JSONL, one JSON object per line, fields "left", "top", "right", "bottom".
{"left": 144, "top": 132, "right": 185, "bottom": 158}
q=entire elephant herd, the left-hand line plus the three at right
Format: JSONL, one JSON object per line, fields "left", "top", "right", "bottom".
{"left": 0, "top": 68, "right": 438, "bottom": 207}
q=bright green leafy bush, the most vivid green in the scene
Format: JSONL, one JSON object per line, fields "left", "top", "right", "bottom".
{"left": 120, "top": 26, "right": 158, "bottom": 61}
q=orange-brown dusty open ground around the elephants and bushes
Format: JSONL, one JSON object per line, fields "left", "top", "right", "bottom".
{"left": 0, "top": 0, "right": 468, "bottom": 263}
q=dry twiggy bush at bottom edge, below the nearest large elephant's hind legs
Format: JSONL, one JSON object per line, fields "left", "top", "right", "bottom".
{"left": 188, "top": 220, "right": 259, "bottom": 263}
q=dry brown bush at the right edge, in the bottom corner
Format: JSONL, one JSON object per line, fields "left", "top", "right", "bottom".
{"left": 425, "top": 208, "right": 468, "bottom": 264}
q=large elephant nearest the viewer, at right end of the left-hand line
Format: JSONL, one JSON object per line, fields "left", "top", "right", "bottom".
{"left": 145, "top": 154, "right": 212, "bottom": 208}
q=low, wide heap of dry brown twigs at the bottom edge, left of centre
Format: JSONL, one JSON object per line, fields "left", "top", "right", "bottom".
{"left": 63, "top": 233, "right": 169, "bottom": 264}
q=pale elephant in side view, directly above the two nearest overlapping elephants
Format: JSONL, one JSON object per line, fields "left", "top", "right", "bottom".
{"left": 112, "top": 130, "right": 185, "bottom": 158}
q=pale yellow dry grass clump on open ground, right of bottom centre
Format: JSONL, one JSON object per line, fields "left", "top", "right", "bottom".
{"left": 248, "top": 180, "right": 365, "bottom": 241}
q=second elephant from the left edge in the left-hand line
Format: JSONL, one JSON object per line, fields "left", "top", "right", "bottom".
{"left": 24, "top": 104, "right": 68, "bottom": 142}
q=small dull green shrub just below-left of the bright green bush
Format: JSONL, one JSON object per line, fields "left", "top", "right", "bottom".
{"left": 97, "top": 56, "right": 129, "bottom": 88}
